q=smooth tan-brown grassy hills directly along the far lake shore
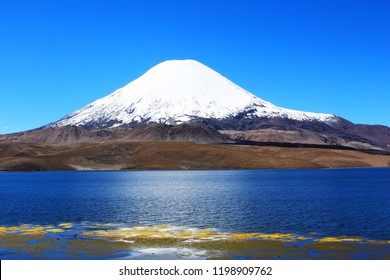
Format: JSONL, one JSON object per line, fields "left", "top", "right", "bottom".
{"left": 0, "top": 141, "right": 390, "bottom": 171}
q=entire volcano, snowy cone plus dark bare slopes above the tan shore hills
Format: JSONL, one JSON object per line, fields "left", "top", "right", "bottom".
{"left": 6, "top": 60, "right": 390, "bottom": 150}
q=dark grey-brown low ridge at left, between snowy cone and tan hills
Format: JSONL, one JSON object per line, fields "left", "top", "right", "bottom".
{"left": 0, "top": 123, "right": 234, "bottom": 144}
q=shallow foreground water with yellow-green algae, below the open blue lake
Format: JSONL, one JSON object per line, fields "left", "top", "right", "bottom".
{"left": 0, "top": 222, "right": 390, "bottom": 260}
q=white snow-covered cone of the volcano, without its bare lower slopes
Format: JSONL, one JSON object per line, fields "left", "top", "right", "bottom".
{"left": 48, "top": 60, "right": 337, "bottom": 127}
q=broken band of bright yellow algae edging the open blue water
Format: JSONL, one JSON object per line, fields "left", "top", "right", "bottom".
{"left": 0, "top": 223, "right": 390, "bottom": 249}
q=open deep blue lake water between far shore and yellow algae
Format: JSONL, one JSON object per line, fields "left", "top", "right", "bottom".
{"left": 0, "top": 168, "right": 390, "bottom": 240}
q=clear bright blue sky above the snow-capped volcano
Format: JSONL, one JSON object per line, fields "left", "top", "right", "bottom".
{"left": 0, "top": 0, "right": 390, "bottom": 133}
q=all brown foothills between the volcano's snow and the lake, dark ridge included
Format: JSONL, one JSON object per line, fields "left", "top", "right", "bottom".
{"left": 0, "top": 124, "right": 390, "bottom": 171}
